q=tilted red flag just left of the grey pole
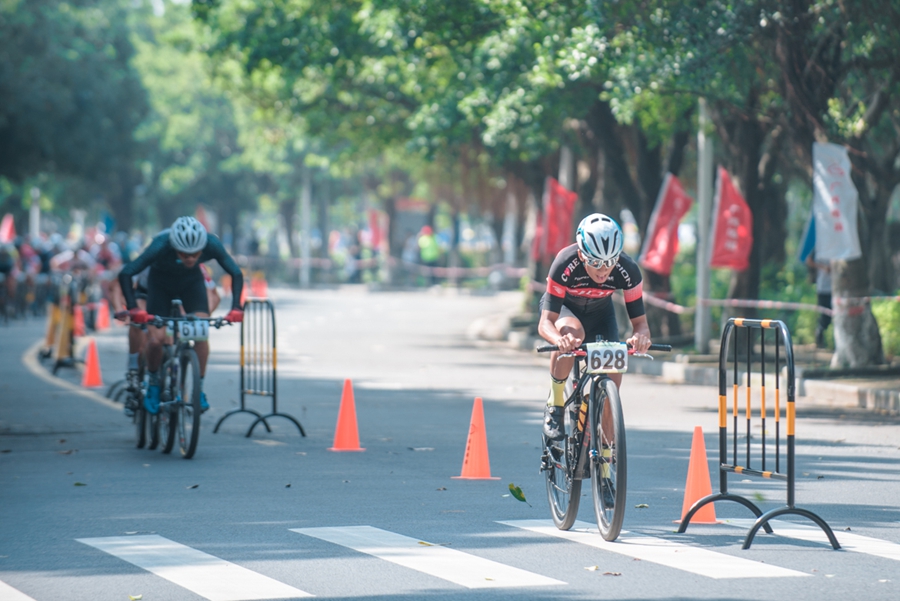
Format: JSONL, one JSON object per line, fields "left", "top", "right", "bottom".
{"left": 639, "top": 173, "right": 694, "bottom": 275}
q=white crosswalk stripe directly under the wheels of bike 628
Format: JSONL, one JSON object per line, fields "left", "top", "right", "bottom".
{"left": 497, "top": 520, "right": 809, "bottom": 579}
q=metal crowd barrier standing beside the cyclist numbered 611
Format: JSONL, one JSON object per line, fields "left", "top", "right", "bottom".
{"left": 213, "top": 298, "right": 306, "bottom": 437}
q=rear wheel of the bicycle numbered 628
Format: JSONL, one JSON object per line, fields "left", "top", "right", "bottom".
{"left": 544, "top": 379, "right": 582, "bottom": 530}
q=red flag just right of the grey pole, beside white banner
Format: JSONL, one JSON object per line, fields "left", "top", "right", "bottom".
{"left": 709, "top": 167, "right": 753, "bottom": 271}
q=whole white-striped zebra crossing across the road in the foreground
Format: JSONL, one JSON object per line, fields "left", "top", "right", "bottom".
{"left": 0, "top": 520, "right": 900, "bottom": 601}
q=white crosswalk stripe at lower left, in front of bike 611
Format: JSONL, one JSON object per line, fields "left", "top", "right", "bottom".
{"left": 76, "top": 534, "right": 312, "bottom": 601}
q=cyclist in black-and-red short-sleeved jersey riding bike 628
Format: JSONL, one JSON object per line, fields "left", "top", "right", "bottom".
{"left": 538, "top": 213, "right": 650, "bottom": 440}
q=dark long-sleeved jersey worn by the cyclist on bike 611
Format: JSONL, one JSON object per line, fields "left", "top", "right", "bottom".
{"left": 119, "top": 230, "right": 244, "bottom": 312}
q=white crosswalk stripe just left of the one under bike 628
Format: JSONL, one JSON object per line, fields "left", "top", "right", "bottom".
{"left": 290, "top": 526, "right": 566, "bottom": 588}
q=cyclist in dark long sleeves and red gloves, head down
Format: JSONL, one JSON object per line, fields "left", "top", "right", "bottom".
{"left": 119, "top": 217, "right": 244, "bottom": 414}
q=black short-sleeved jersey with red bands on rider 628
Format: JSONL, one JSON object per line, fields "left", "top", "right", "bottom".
{"left": 542, "top": 244, "right": 644, "bottom": 319}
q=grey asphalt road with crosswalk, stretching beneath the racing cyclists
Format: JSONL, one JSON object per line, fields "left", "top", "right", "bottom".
{"left": 0, "top": 287, "right": 900, "bottom": 601}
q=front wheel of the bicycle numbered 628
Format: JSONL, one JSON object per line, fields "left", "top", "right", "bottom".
{"left": 591, "top": 378, "right": 627, "bottom": 541}
